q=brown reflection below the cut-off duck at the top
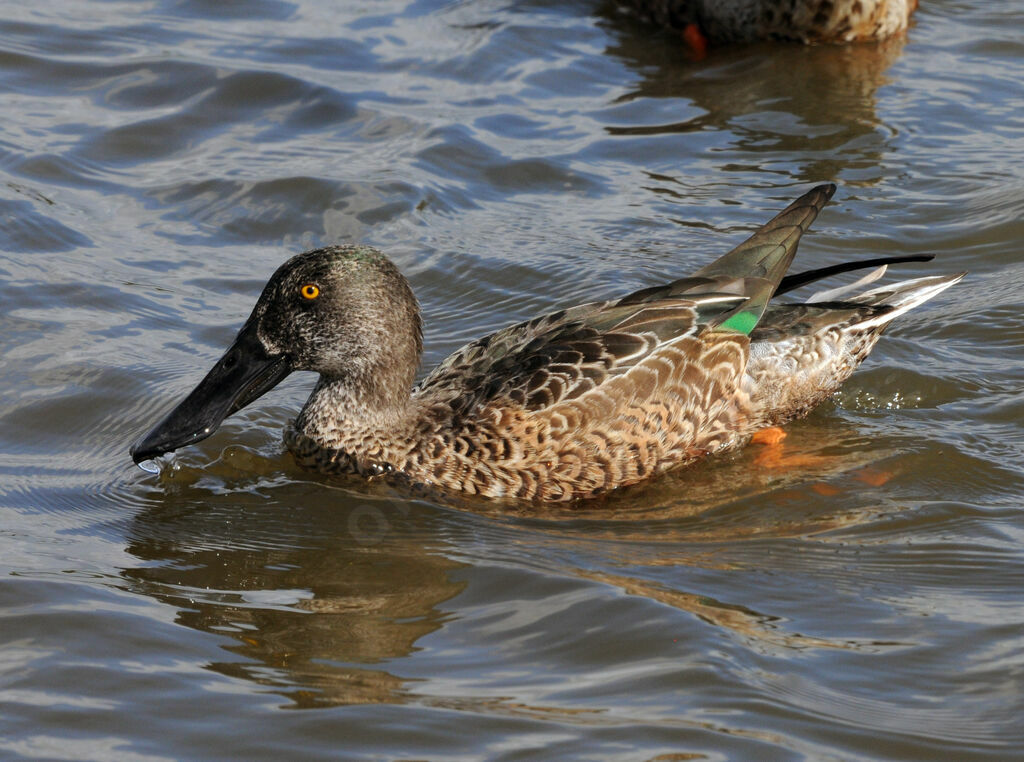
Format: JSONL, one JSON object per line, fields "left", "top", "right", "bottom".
{"left": 605, "top": 12, "right": 905, "bottom": 186}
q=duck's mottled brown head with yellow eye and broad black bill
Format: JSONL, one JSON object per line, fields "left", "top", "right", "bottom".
{"left": 130, "top": 246, "right": 423, "bottom": 463}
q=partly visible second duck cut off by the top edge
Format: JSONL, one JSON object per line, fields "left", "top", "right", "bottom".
{"left": 624, "top": 0, "right": 918, "bottom": 42}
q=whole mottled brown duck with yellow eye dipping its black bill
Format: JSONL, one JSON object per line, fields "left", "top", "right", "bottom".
{"left": 131, "top": 185, "right": 965, "bottom": 501}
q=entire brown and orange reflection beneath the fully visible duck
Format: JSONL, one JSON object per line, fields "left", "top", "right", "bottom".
{"left": 116, "top": 417, "right": 909, "bottom": 711}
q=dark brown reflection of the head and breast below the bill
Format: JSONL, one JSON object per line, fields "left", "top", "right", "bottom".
{"left": 123, "top": 491, "right": 465, "bottom": 707}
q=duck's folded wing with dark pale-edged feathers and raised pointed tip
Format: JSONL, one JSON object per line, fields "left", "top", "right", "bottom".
{"left": 415, "top": 185, "right": 836, "bottom": 417}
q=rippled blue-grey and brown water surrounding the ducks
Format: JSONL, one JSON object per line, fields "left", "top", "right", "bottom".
{"left": 0, "top": 0, "right": 1024, "bottom": 760}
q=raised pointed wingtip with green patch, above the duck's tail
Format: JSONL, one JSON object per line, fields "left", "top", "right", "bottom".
{"left": 693, "top": 183, "right": 836, "bottom": 334}
